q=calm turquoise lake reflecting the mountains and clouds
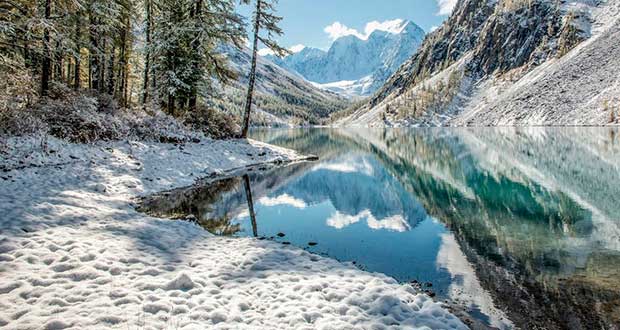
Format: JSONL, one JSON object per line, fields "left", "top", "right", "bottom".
{"left": 143, "top": 128, "right": 620, "bottom": 329}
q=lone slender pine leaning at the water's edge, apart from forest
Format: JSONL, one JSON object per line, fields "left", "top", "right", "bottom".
{"left": 241, "top": 0, "right": 289, "bottom": 138}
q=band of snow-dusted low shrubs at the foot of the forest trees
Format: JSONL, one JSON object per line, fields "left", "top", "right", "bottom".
{"left": 0, "top": 85, "right": 238, "bottom": 143}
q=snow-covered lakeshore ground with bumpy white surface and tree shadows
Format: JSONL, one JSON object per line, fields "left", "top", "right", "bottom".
{"left": 0, "top": 135, "right": 466, "bottom": 329}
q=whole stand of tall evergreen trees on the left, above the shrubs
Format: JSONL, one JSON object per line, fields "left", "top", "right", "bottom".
{"left": 0, "top": 0, "right": 252, "bottom": 114}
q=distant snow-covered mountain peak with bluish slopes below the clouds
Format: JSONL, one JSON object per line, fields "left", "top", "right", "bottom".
{"left": 267, "top": 21, "right": 425, "bottom": 95}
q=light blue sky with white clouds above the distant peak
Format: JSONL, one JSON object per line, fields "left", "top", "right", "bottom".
{"left": 239, "top": 0, "right": 456, "bottom": 49}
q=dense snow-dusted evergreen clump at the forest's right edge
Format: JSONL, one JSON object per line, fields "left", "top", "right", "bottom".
{"left": 148, "top": 0, "right": 243, "bottom": 114}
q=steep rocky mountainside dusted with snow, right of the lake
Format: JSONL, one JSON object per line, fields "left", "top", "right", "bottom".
{"left": 340, "top": 0, "right": 620, "bottom": 126}
